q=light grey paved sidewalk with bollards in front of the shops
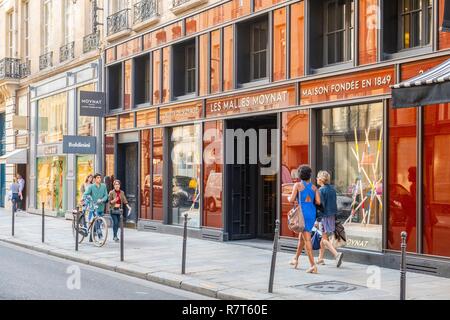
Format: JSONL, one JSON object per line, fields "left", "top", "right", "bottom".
{"left": 0, "top": 209, "right": 450, "bottom": 300}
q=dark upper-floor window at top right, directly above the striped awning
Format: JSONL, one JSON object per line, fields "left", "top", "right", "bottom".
{"left": 383, "top": 0, "right": 433, "bottom": 57}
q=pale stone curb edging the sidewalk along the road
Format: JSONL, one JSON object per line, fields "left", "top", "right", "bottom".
{"left": 0, "top": 238, "right": 276, "bottom": 300}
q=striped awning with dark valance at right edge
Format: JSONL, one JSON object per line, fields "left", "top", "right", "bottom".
{"left": 392, "top": 59, "right": 450, "bottom": 108}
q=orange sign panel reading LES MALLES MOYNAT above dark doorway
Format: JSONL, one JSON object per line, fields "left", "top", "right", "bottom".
{"left": 206, "top": 86, "right": 295, "bottom": 118}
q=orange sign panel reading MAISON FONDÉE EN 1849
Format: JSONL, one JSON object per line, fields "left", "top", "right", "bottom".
{"left": 300, "top": 67, "right": 395, "bottom": 105}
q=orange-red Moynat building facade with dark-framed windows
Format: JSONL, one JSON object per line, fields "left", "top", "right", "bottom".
{"left": 104, "top": 0, "right": 450, "bottom": 274}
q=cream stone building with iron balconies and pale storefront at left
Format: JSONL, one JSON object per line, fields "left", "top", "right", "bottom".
{"left": 0, "top": 0, "right": 103, "bottom": 215}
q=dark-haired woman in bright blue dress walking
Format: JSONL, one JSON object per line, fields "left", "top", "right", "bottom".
{"left": 288, "top": 165, "right": 320, "bottom": 273}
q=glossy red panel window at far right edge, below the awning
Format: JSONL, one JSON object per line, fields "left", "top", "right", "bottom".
{"left": 423, "top": 104, "right": 450, "bottom": 257}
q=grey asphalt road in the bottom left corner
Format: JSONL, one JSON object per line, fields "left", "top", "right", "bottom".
{"left": 0, "top": 244, "right": 211, "bottom": 300}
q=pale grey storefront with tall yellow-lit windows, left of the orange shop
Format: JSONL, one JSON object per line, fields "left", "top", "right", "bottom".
{"left": 29, "top": 62, "right": 102, "bottom": 216}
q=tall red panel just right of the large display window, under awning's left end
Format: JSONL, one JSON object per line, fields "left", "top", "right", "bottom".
{"left": 388, "top": 108, "right": 417, "bottom": 252}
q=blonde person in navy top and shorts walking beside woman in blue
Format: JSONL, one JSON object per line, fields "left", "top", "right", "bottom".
{"left": 317, "top": 171, "right": 343, "bottom": 268}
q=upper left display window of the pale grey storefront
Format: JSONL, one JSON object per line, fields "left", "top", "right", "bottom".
{"left": 38, "top": 92, "right": 67, "bottom": 144}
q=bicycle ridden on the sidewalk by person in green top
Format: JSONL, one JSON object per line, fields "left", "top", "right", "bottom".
{"left": 72, "top": 196, "right": 108, "bottom": 247}
